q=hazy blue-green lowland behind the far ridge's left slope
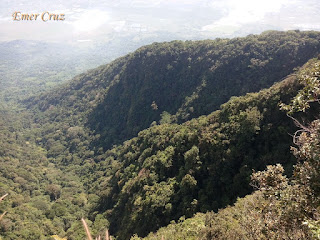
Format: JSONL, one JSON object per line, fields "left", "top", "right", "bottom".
{"left": 0, "top": 31, "right": 190, "bottom": 101}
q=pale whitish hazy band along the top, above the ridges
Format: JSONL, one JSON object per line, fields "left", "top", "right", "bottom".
{"left": 0, "top": 0, "right": 320, "bottom": 43}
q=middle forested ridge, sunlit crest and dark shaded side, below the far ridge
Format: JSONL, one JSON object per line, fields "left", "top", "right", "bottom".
{"left": 88, "top": 72, "right": 299, "bottom": 239}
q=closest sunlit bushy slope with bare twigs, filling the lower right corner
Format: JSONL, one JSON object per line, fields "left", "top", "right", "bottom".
{"left": 132, "top": 56, "right": 320, "bottom": 240}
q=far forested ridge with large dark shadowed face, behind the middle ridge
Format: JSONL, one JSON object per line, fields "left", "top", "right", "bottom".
{"left": 29, "top": 31, "right": 320, "bottom": 150}
